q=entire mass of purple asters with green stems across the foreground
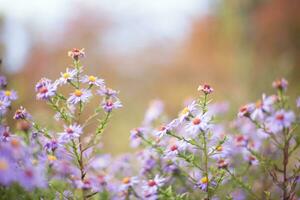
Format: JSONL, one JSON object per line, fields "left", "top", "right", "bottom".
{"left": 0, "top": 49, "right": 300, "bottom": 200}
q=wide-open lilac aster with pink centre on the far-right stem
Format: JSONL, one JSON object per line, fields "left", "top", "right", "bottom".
{"left": 267, "top": 109, "right": 295, "bottom": 133}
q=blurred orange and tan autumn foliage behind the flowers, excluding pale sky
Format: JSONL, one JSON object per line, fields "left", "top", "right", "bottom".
{"left": 0, "top": 0, "right": 300, "bottom": 153}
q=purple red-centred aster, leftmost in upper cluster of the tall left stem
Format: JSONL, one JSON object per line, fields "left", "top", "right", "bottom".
{"left": 35, "top": 78, "right": 57, "bottom": 100}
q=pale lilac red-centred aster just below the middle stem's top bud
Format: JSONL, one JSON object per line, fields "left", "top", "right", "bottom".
{"left": 186, "top": 114, "right": 210, "bottom": 137}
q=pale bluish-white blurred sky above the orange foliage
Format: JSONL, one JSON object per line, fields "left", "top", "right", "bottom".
{"left": 0, "top": 0, "right": 212, "bottom": 72}
